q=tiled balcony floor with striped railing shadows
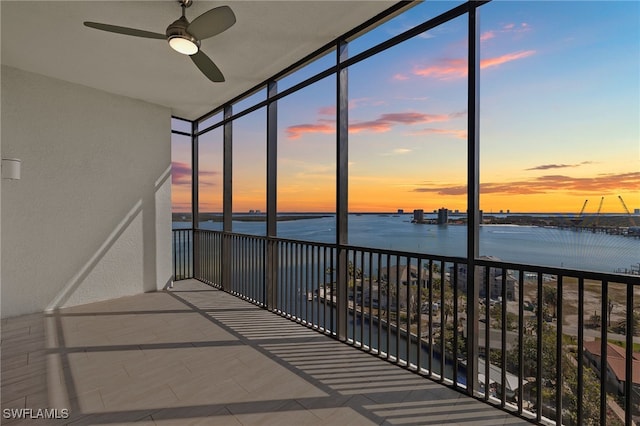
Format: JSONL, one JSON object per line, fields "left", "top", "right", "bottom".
{"left": 0, "top": 280, "right": 528, "bottom": 425}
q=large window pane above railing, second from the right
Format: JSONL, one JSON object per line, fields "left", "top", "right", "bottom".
{"left": 349, "top": 17, "right": 467, "bottom": 256}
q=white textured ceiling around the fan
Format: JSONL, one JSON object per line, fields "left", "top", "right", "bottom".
{"left": 0, "top": 0, "right": 404, "bottom": 119}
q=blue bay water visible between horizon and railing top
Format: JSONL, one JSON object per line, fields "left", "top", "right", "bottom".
{"left": 174, "top": 214, "right": 640, "bottom": 272}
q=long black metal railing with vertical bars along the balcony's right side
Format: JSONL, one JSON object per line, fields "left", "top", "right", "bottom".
{"left": 182, "top": 230, "right": 640, "bottom": 425}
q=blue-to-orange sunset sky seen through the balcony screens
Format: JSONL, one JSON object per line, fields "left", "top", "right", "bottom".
{"left": 172, "top": 1, "right": 640, "bottom": 213}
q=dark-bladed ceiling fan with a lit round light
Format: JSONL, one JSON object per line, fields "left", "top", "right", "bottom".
{"left": 84, "top": 0, "right": 236, "bottom": 82}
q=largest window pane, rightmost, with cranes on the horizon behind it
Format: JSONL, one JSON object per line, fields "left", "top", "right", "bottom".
{"left": 480, "top": 2, "right": 640, "bottom": 272}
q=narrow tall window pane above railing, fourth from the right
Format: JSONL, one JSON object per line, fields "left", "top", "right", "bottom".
{"left": 232, "top": 108, "right": 267, "bottom": 235}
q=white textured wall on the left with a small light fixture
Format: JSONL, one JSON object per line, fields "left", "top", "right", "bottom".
{"left": 0, "top": 66, "right": 171, "bottom": 317}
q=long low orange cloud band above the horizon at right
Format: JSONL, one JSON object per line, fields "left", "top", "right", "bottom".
{"left": 413, "top": 172, "right": 640, "bottom": 195}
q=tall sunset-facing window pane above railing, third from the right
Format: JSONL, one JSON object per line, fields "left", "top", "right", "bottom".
{"left": 277, "top": 76, "right": 336, "bottom": 242}
